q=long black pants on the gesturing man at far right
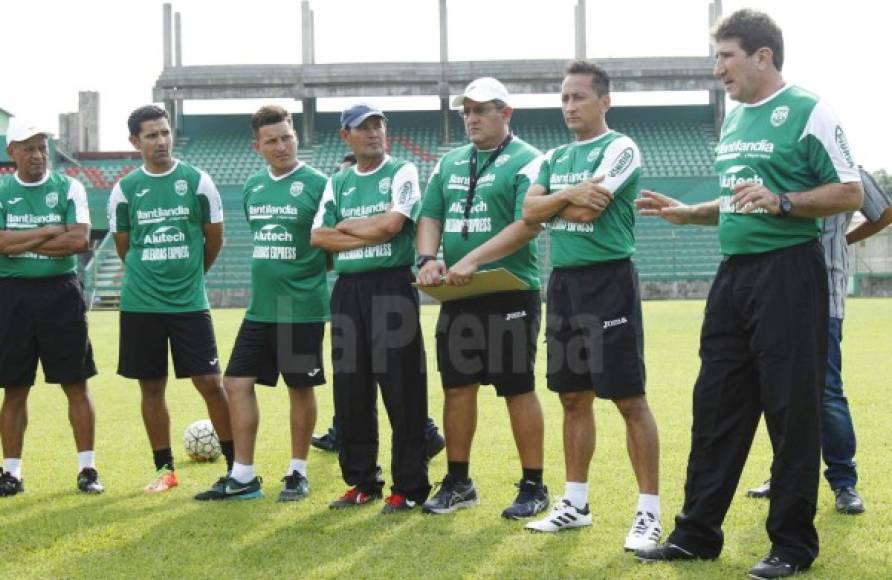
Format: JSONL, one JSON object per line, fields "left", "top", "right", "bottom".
{"left": 668, "top": 242, "right": 828, "bottom": 565}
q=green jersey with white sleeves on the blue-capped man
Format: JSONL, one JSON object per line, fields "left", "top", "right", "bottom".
{"left": 313, "top": 155, "right": 421, "bottom": 274}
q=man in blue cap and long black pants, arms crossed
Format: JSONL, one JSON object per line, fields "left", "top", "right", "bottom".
{"left": 311, "top": 104, "right": 430, "bottom": 514}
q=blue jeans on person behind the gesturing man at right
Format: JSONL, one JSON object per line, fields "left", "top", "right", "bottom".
{"left": 821, "top": 318, "right": 858, "bottom": 490}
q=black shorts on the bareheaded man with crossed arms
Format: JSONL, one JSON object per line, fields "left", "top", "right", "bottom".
{"left": 545, "top": 260, "right": 645, "bottom": 399}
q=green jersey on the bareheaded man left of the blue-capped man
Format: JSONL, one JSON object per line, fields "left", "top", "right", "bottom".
{"left": 244, "top": 163, "right": 330, "bottom": 322}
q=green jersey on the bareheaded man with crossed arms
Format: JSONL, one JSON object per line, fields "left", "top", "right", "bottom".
{"left": 536, "top": 131, "right": 641, "bottom": 268}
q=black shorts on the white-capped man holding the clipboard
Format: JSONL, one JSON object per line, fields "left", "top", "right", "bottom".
{"left": 437, "top": 290, "right": 542, "bottom": 397}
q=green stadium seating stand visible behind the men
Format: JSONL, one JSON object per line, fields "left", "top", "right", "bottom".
{"left": 75, "top": 106, "right": 721, "bottom": 307}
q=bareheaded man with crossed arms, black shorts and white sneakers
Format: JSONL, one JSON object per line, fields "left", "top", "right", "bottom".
{"left": 524, "top": 61, "right": 661, "bottom": 550}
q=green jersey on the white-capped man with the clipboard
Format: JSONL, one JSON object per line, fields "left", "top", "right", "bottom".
{"left": 421, "top": 137, "right": 542, "bottom": 289}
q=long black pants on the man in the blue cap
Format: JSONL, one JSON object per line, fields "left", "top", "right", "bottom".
{"left": 331, "top": 266, "right": 430, "bottom": 501}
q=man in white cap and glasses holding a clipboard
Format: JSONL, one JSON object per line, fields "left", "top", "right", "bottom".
{"left": 417, "top": 77, "right": 549, "bottom": 518}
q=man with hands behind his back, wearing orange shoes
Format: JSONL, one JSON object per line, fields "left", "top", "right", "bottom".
{"left": 108, "top": 105, "right": 233, "bottom": 493}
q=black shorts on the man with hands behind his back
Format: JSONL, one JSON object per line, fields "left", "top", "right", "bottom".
{"left": 118, "top": 310, "right": 220, "bottom": 379}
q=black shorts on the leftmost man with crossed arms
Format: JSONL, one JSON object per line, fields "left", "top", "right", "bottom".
{"left": 0, "top": 274, "right": 96, "bottom": 387}
